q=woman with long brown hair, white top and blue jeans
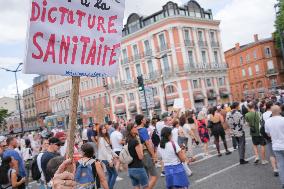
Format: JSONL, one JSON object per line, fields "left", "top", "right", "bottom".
{"left": 98, "top": 125, "right": 118, "bottom": 189}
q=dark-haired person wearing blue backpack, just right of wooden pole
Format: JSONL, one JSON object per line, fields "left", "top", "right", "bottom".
{"left": 75, "top": 143, "right": 109, "bottom": 189}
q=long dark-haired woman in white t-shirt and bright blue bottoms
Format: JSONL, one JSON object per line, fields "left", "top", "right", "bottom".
{"left": 158, "top": 127, "right": 189, "bottom": 189}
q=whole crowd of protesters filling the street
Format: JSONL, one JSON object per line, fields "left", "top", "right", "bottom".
{"left": 0, "top": 95, "right": 284, "bottom": 189}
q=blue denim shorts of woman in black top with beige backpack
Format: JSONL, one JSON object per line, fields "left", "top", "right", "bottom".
{"left": 128, "top": 168, "right": 149, "bottom": 188}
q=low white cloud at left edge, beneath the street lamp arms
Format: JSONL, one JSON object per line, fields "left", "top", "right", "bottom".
{"left": 0, "top": 79, "right": 30, "bottom": 97}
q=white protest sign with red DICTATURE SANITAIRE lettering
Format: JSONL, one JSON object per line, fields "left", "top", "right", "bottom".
{"left": 24, "top": 0, "right": 125, "bottom": 77}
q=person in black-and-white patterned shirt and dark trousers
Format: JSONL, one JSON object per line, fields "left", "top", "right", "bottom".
{"left": 226, "top": 102, "right": 248, "bottom": 165}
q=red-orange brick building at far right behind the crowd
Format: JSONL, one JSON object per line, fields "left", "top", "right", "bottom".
{"left": 225, "top": 35, "right": 284, "bottom": 100}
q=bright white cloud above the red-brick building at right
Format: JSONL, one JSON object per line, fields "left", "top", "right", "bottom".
{"left": 215, "top": 0, "right": 276, "bottom": 51}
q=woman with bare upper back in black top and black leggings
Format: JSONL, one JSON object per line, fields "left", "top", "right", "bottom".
{"left": 208, "top": 106, "right": 232, "bottom": 157}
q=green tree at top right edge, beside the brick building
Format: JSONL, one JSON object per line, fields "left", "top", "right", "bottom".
{"left": 274, "top": 0, "right": 284, "bottom": 49}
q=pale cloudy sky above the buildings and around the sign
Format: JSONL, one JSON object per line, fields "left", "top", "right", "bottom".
{"left": 0, "top": 0, "right": 276, "bottom": 97}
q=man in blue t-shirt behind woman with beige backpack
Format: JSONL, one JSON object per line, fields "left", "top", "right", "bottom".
{"left": 135, "top": 114, "right": 158, "bottom": 189}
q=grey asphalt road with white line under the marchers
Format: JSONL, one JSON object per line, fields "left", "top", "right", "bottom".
{"left": 28, "top": 131, "right": 281, "bottom": 189}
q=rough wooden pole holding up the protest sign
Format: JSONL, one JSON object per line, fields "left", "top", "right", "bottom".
{"left": 66, "top": 76, "right": 80, "bottom": 168}
